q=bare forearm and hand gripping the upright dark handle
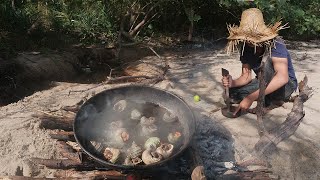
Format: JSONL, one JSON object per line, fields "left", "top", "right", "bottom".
{"left": 222, "top": 64, "right": 251, "bottom": 87}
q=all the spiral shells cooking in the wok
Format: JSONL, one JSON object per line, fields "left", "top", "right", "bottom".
{"left": 97, "top": 100, "right": 181, "bottom": 166}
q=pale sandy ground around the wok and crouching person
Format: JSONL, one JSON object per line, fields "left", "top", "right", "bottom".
{"left": 0, "top": 40, "right": 320, "bottom": 179}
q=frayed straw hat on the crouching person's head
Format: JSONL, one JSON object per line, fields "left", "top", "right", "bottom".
{"left": 227, "top": 8, "right": 286, "bottom": 53}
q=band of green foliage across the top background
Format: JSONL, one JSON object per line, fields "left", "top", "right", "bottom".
{"left": 0, "top": 0, "right": 320, "bottom": 52}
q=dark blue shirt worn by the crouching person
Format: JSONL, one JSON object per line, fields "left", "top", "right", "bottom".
{"left": 240, "top": 39, "right": 298, "bottom": 88}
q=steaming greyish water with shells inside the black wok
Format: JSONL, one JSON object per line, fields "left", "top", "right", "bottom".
{"left": 80, "top": 99, "right": 184, "bottom": 165}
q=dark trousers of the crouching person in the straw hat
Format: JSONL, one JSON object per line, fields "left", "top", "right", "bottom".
{"left": 230, "top": 57, "right": 295, "bottom": 106}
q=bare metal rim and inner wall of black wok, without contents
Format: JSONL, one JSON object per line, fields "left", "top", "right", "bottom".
{"left": 74, "top": 85, "right": 195, "bottom": 170}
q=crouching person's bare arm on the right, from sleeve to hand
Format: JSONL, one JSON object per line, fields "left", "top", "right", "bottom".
{"left": 235, "top": 57, "right": 289, "bottom": 114}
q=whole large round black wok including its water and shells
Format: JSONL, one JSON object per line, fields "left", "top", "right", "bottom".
{"left": 73, "top": 85, "right": 195, "bottom": 170}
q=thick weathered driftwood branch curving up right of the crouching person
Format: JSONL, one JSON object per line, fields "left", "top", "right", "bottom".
{"left": 255, "top": 76, "right": 313, "bottom": 154}
